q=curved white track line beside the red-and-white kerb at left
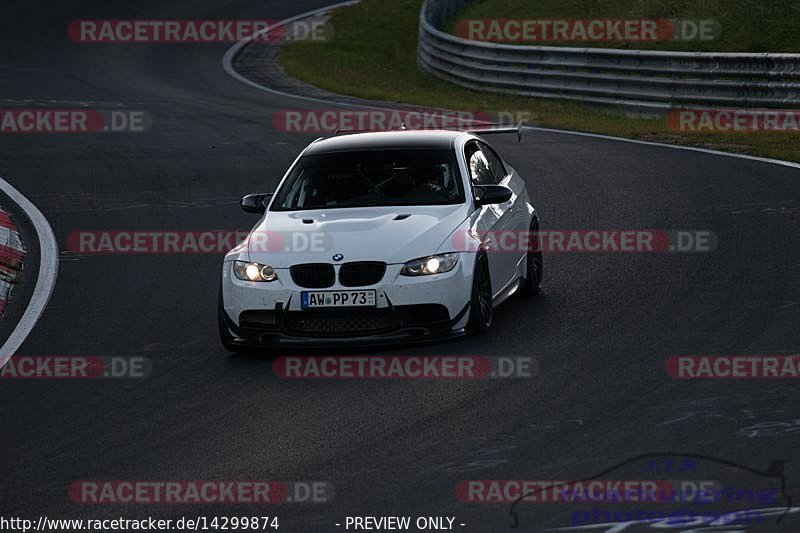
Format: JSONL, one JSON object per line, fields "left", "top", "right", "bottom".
{"left": 0, "top": 178, "right": 58, "bottom": 368}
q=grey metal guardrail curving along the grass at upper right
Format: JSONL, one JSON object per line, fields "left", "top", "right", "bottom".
{"left": 417, "top": 0, "right": 800, "bottom": 110}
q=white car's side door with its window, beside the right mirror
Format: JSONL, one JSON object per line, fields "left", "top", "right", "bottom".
{"left": 464, "top": 140, "right": 515, "bottom": 295}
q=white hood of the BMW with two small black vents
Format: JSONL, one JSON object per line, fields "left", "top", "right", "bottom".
{"left": 247, "top": 204, "right": 467, "bottom": 268}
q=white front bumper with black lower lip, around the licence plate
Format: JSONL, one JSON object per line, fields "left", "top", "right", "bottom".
{"left": 220, "top": 254, "right": 473, "bottom": 347}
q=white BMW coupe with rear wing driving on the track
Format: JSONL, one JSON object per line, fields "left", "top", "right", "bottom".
{"left": 219, "top": 124, "right": 542, "bottom": 352}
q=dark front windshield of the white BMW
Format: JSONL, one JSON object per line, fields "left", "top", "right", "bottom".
{"left": 272, "top": 150, "right": 464, "bottom": 211}
